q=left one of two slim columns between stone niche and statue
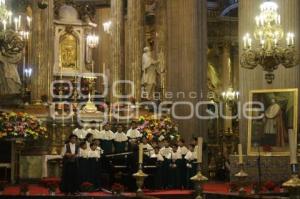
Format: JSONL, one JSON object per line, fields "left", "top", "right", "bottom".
{"left": 110, "top": 0, "right": 125, "bottom": 103}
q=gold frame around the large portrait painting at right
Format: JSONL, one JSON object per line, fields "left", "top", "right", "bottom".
{"left": 247, "top": 88, "right": 298, "bottom": 156}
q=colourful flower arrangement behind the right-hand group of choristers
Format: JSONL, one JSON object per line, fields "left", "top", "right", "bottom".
{"left": 138, "top": 116, "right": 180, "bottom": 141}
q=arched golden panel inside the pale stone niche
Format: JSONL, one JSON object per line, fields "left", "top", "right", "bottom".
{"left": 59, "top": 33, "right": 78, "bottom": 69}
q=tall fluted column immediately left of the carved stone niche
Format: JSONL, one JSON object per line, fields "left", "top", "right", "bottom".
{"left": 29, "top": 0, "right": 54, "bottom": 103}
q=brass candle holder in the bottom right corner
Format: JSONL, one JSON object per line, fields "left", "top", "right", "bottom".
{"left": 282, "top": 164, "right": 300, "bottom": 199}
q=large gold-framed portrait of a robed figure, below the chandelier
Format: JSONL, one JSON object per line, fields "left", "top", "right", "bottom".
{"left": 247, "top": 88, "right": 298, "bottom": 156}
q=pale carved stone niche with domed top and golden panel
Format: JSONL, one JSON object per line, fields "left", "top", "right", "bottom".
{"left": 53, "top": 4, "right": 95, "bottom": 76}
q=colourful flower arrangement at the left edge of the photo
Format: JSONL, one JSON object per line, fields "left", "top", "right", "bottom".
{"left": 0, "top": 112, "right": 47, "bottom": 139}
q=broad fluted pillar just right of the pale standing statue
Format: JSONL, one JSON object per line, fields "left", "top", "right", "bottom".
{"left": 166, "top": 0, "right": 207, "bottom": 139}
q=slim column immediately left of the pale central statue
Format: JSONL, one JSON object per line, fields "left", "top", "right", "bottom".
{"left": 125, "top": 0, "right": 144, "bottom": 101}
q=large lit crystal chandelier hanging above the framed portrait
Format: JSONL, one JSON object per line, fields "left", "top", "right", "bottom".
{"left": 241, "top": 1, "right": 297, "bottom": 83}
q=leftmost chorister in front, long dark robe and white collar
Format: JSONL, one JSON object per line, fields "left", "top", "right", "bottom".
{"left": 61, "top": 134, "right": 79, "bottom": 194}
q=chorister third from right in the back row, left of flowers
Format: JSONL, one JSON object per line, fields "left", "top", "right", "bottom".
{"left": 100, "top": 124, "right": 115, "bottom": 154}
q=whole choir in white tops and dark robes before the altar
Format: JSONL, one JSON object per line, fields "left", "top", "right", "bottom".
{"left": 61, "top": 122, "right": 198, "bottom": 194}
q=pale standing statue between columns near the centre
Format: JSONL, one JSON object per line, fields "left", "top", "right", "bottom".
{"left": 142, "top": 47, "right": 159, "bottom": 98}
